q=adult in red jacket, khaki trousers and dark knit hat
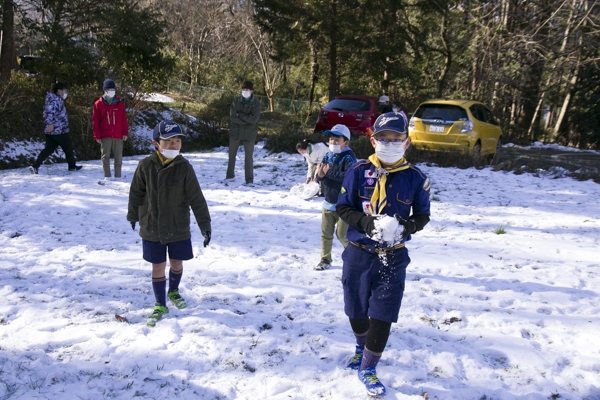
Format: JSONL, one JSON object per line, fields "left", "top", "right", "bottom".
{"left": 92, "top": 79, "right": 129, "bottom": 180}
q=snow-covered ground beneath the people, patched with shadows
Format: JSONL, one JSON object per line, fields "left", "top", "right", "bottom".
{"left": 0, "top": 145, "right": 600, "bottom": 400}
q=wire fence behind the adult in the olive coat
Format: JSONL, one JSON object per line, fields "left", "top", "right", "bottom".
{"left": 167, "top": 80, "right": 320, "bottom": 115}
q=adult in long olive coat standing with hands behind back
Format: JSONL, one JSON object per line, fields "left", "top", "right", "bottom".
{"left": 225, "top": 81, "right": 260, "bottom": 185}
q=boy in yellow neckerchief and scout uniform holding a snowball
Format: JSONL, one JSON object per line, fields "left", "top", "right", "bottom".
{"left": 336, "top": 112, "right": 429, "bottom": 396}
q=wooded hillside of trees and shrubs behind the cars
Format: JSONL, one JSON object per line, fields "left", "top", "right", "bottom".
{"left": 0, "top": 0, "right": 600, "bottom": 148}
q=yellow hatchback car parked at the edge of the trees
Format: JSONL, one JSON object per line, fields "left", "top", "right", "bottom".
{"left": 408, "top": 100, "right": 502, "bottom": 159}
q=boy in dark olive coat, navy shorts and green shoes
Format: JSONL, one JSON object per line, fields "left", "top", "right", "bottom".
{"left": 127, "top": 121, "right": 211, "bottom": 326}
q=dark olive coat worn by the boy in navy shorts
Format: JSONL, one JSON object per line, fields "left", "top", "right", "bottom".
{"left": 127, "top": 153, "right": 211, "bottom": 244}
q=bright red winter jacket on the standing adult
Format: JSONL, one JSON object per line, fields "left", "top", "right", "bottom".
{"left": 92, "top": 96, "right": 129, "bottom": 139}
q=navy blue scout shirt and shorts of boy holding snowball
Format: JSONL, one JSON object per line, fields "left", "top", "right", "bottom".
{"left": 337, "top": 160, "right": 430, "bottom": 322}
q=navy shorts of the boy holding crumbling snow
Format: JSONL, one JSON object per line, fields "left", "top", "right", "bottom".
{"left": 342, "top": 243, "right": 410, "bottom": 322}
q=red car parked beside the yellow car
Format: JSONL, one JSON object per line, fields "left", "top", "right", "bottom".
{"left": 315, "top": 95, "right": 381, "bottom": 136}
